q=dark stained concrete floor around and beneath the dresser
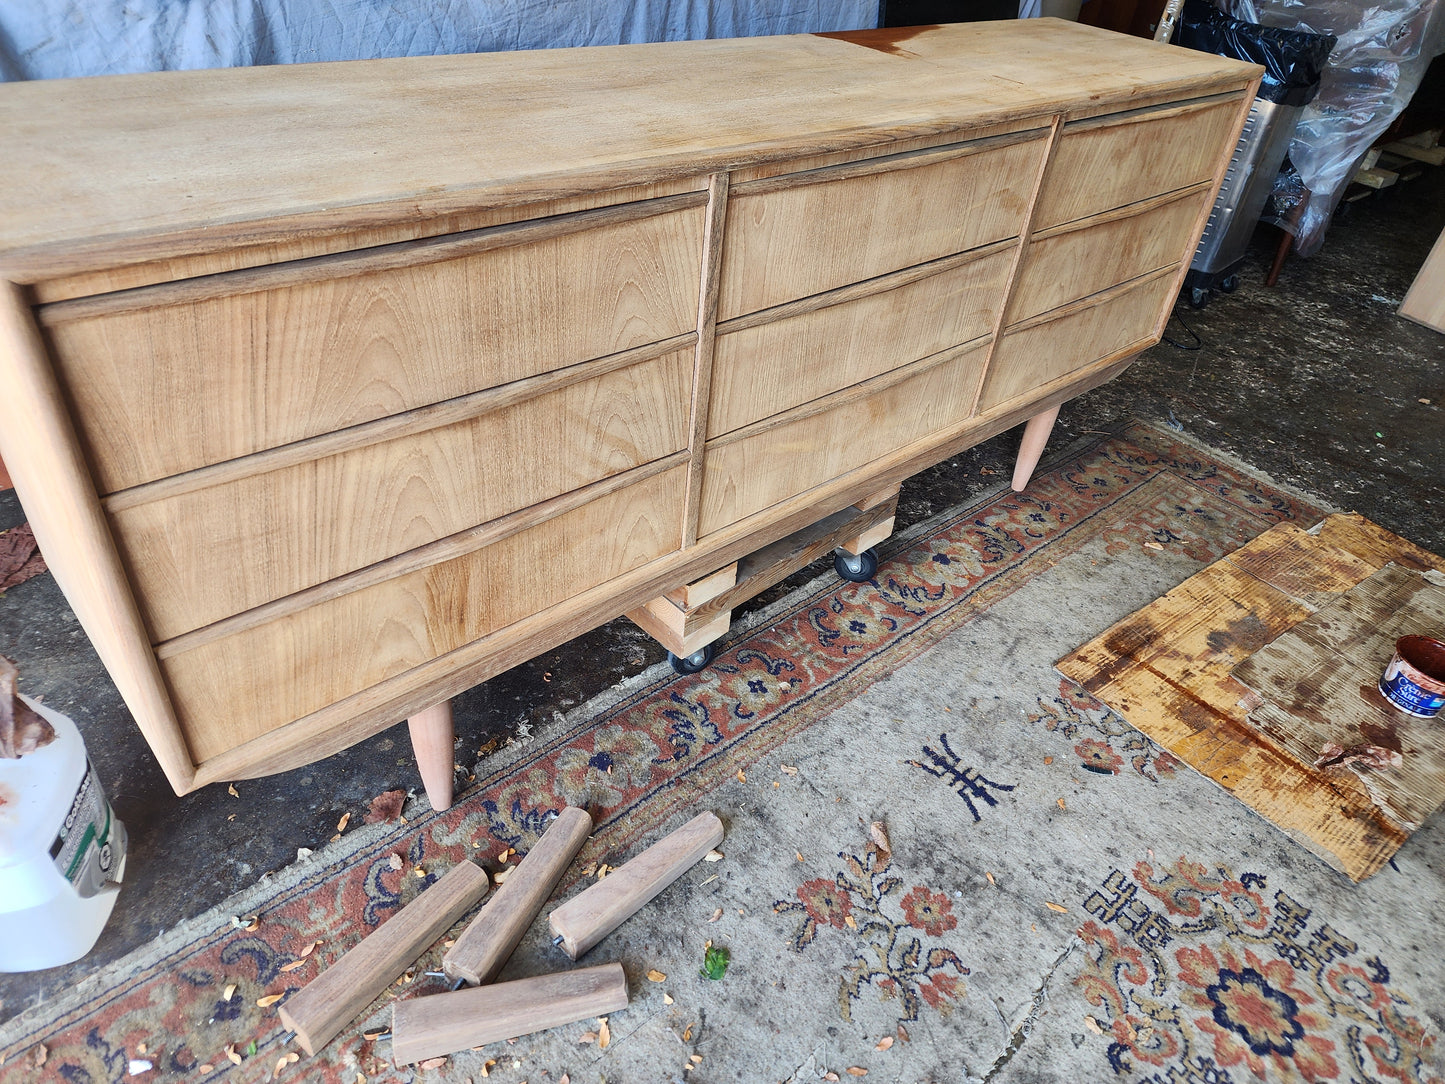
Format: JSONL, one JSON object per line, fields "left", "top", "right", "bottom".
{"left": 0, "top": 169, "right": 1445, "bottom": 1020}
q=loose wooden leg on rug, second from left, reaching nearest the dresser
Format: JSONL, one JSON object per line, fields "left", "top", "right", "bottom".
{"left": 442, "top": 805, "right": 592, "bottom": 986}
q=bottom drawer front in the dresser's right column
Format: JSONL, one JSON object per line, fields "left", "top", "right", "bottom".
{"left": 978, "top": 272, "right": 1175, "bottom": 410}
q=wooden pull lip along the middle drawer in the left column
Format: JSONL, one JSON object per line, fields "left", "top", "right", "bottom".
{"left": 101, "top": 331, "right": 698, "bottom": 513}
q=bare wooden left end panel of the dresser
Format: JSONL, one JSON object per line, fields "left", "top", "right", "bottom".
{"left": 0, "top": 280, "right": 195, "bottom": 793}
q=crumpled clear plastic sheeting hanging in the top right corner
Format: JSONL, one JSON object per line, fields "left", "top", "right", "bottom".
{"left": 1218, "top": 0, "right": 1445, "bottom": 256}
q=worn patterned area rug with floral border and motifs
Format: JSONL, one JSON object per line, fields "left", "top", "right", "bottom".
{"left": 0, "top": 426, "right": 1445, "bottom": 1084}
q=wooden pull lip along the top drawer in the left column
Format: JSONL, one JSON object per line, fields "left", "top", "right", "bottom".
{"left": 35, "top": 192, "right": 708, "bottom": 327}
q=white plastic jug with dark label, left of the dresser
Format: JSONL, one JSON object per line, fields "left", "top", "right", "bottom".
{"left": 0, "top": 695, "right": 126, "bottom": 971}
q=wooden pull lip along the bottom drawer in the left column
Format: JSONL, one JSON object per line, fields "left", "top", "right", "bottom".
{"left": 155, "top": 449, "right": 688, "bottom": 659}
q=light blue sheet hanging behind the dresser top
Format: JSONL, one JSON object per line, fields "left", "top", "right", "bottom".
{"left": 0, "top": 0, "right": 879, "bottom": 81}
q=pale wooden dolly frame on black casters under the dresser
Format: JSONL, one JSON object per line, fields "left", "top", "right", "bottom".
{"left": 627, "top": 486, "right": 899, "bottom": 659}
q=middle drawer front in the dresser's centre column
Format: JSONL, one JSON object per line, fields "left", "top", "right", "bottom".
{"left": 708, "top": 249, "right": 1014, "bottom": 436}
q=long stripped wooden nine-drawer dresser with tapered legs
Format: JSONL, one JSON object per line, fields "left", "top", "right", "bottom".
{"left": 0, "top": 19, "right": 1259, "bottom": 804}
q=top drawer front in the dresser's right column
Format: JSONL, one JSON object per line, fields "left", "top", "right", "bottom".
{"left": 1033, "top": 98, "right": 1243, "bottom": 231}
